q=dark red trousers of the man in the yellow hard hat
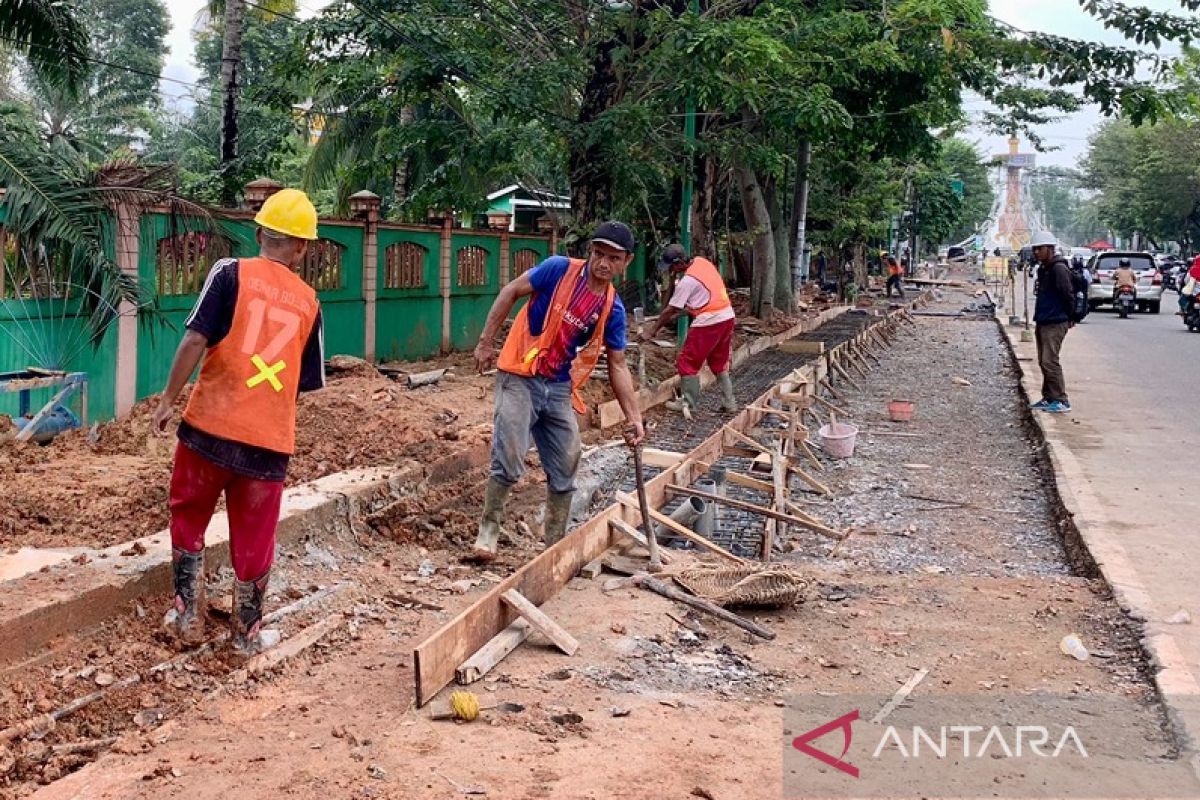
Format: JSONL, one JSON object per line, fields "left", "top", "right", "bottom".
{"left": 170, "top": 443, "right": 283, "bottom": 582}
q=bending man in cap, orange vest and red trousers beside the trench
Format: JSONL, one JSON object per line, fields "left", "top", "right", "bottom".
{"left": 646, "top": 245, "right": 738, "bottom": 413}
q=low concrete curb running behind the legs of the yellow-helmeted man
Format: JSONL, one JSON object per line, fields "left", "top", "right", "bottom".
{"left": 0, "top": 444, "right": 491, "bottom": 664}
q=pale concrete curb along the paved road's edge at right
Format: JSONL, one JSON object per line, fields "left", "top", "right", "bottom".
{"left": 996, "top": 319, "right": 1200, "bottom": 762}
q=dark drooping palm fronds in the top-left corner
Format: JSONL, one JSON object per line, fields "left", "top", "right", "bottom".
{"left": 0, "top": 0, "right": 89, "bottom": 90}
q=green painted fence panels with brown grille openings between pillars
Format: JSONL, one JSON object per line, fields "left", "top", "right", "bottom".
{"left": 0, "top": 199, "right": 550, "bottom": 420}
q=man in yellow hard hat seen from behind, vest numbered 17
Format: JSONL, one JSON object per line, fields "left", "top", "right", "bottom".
{"left": 154, "top": 190, "right": 325, "bottom": 655}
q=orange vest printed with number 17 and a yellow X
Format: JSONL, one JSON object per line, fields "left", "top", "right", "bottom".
{"left": 184, "top": 258, "right": 318, "bottom": 455}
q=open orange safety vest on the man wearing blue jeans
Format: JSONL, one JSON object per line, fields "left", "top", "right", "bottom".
{"left": 496, "top": 258, "right": 617, "bottom": 414}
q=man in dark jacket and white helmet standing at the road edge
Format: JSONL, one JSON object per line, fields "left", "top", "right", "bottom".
{"left": 1031, "top": 230, "right": 1075, "bottom": 414}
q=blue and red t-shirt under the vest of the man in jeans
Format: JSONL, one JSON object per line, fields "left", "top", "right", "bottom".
{"left": 529, "top": 255, "right": 625, "bottom": 383}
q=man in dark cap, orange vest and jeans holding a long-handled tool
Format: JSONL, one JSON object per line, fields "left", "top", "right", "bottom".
{"left": 472, "top": 222, "right": 646, "bottom": 561}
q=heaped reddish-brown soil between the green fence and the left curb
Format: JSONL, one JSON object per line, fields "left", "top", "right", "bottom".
{"left": 0, "top": 357, "right": 491, "bottom": 549}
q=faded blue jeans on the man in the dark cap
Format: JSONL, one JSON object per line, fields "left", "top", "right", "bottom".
{"left": 491, "top": 372, "right": 580, "bottom": 493}
